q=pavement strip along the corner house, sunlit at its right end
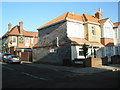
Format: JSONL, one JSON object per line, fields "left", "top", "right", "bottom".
{"left": 22, "top": 62, "right": 120, "bottom": 75}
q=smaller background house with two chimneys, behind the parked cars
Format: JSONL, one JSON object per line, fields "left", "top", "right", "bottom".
{"left": 2, "top": 21, "right": 38, "bottom": 61}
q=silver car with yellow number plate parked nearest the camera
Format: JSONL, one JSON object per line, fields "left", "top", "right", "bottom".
{"left": 4, "top": 55, "right": 21, "bottom": 64}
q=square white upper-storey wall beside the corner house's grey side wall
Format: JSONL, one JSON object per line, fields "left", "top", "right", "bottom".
{"left": 67, "top": 21, "right": 84, "bottom": 38}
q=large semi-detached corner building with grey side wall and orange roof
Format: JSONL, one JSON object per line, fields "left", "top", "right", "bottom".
{"left": 33, "top": 9, "right": 119, "bottom": 64}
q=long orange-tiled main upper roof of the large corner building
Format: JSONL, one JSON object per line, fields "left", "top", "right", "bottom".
{"left": 38, "top": 12, "right": 109, "bottom": 30}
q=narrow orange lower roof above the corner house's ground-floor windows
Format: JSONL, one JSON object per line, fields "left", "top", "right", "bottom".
{"left": 69, "top": 38, "right": 104, "bottom": 46}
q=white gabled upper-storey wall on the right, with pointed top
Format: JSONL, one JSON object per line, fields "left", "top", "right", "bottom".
{"left": 102, "top": 20, "right": 114, "bottom": 39}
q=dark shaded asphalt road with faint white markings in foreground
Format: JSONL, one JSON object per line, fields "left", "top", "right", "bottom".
{"left": 2, "top": 63, "right": 120, "bottom": 89}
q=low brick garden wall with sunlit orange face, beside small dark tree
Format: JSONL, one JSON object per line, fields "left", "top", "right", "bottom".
{"left": 85, "top": 57, "right": 108, "bottom": 67}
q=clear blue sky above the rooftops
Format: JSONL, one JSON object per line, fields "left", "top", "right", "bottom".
{"left": 0, "top": 2, "right": 118, "bottom": 37}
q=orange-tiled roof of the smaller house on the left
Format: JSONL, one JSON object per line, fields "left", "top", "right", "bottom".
{"left": 3, "top": 25, "right": 38, "bottom": 37}
